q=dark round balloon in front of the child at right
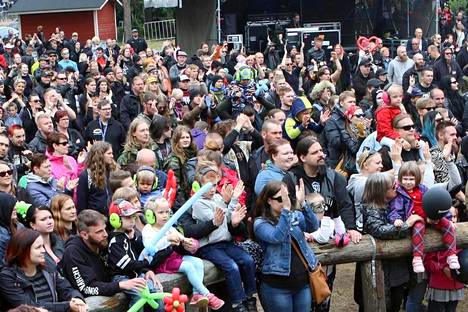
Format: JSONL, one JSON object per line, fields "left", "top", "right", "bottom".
{"left": 422, "top": 186, "right": 452, "bottom": 220}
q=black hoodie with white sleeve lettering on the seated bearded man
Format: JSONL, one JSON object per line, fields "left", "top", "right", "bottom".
{"left": 59, "top": 235, "right": 120, "bottom": 297}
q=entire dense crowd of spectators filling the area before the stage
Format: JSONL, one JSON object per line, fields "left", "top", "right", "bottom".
{"left": 0, "top": 4, "right": 468, "bottom": 312}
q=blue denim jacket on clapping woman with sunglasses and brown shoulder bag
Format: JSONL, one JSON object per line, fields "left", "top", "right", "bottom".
{"left": 254, "top": 207, "right": 318, "bottom": 276}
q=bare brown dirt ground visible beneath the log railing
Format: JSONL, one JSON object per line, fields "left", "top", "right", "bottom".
{"left": 330, "top": 263, "right": 468, "bottom": 312}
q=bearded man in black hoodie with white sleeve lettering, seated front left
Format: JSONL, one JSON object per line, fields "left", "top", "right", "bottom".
{"left": 59, "top": 209, "right": 146, "bottom": 302}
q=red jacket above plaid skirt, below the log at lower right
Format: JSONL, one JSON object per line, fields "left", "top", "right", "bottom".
{"left": 424, "top": 250, "right": 464, "bottom": 290}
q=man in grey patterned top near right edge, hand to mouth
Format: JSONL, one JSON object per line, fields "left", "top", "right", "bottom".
{"left": 430, "top": 121, "right": 458, "bottom": 183}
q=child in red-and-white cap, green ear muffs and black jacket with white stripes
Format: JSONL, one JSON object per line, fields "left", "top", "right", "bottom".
{"left": 108, "top": 199, "right": 163, "bottom": 311}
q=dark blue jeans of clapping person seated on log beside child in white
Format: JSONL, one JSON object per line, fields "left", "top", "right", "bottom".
{"left": 197, "top": 242, "right": 256, "bottom": 304}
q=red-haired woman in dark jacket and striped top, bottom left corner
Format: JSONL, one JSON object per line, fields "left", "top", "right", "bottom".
{"left": 0, "top": 229, "right": 88, "bottom": 312}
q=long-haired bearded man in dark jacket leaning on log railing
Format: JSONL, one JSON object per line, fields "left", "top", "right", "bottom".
{"left": 283, "top": 136, "right": 362, "bottom": 311}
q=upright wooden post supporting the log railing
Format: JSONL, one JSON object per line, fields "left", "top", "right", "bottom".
{"left": 360, "top": 260, "right": 386, "bottom": 312}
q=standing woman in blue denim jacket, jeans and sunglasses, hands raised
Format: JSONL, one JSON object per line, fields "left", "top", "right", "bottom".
{"left": 254, "top": 180, "right": 318, "bottom": 312}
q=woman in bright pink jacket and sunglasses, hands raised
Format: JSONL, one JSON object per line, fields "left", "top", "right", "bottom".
{"left": 46, "top": 132, "right": 86, "bottom": 188}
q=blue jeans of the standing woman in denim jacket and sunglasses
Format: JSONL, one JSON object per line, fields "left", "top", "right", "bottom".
{"left": 260, "top": 283, "right": 312, "bottom": 312}
